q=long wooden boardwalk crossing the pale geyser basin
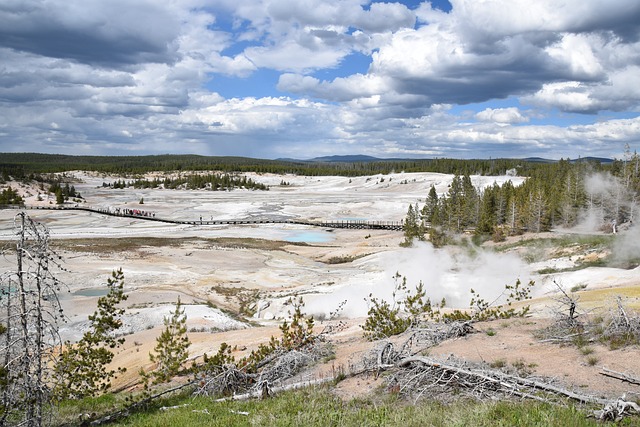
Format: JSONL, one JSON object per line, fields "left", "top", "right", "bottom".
{"left": 0, "top": 205, "right": 403, "bottom": 231}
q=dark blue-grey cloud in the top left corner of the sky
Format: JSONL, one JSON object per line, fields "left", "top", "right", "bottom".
{"left": 0, "top": 0, "right": 178, "bottom": 66}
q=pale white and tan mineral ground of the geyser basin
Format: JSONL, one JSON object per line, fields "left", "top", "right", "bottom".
{"left": 0, "top": 172, "right": 640, "bottom": 396}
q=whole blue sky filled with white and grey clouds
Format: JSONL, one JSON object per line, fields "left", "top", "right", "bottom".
{"left": 0, "top": 0, "right": 640, "bottom": 161}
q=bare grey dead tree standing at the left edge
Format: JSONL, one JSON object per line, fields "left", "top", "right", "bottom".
{"left": 0, "top": 212, "right": 62, "bottom": 427}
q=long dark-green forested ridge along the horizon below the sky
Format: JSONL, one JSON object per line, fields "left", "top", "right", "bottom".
{"left": 0, "top": 153, "right": 616, "bottom": 180}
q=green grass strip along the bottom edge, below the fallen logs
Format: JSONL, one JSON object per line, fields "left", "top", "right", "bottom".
{"left": 87, "top": 388, "right": 612, "bottom": 427}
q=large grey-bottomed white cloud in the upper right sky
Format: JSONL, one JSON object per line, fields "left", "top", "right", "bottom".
{"left": 290, "top": 0, "right": 640, "bottom": 112}
